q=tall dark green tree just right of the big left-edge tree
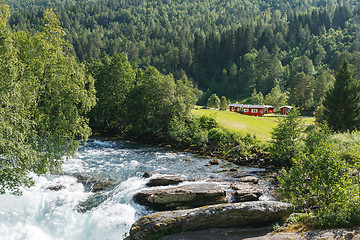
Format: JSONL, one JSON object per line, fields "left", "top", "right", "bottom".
{"left": 89, "top": 54, "right": 136, "bottom": 134}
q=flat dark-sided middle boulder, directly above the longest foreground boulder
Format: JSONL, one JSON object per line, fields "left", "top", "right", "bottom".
{"left": 134, "top": 183, "right": 228, "bottom": 211}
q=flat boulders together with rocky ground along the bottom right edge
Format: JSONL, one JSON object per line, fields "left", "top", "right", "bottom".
{"left": 127, "top": 173, "right": 360, "bottom": 240}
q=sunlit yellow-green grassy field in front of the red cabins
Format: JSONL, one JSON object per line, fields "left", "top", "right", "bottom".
{"left": 193, "top": 107, "right": 315, "bottom": 143}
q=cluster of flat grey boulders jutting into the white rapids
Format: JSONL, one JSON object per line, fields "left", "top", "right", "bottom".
{"left": 129, "top": 173, "right": 294, "bottom": 240}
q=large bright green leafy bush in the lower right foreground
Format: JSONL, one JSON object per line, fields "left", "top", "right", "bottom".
{"left": 279, "top": 126, "right": 360, "bottom": 227}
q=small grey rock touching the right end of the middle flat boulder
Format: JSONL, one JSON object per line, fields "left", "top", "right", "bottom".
{"left": 231, "top": 183, "right": 263, "bottom": 202}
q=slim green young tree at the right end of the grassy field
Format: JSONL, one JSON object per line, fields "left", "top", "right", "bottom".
{"left": 269, "top": 109, "right": 302, "bottom": 167}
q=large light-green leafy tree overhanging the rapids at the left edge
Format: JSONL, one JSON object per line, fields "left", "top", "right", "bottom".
{"left": 0, "top": 4, "right": 95, "bottom": 193}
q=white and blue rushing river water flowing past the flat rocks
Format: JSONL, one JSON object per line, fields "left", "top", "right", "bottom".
{"left": 0, "top": 139, "right": 260, "bottom": 240}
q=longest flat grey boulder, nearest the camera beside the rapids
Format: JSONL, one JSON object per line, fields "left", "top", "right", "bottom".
{"left": 130, "top": 201, "right": 294, "bottom": 240}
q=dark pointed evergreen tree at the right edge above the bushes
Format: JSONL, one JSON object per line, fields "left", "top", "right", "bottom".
{"left": 323, "top": 61, "right": 360, "bottom": 132}
